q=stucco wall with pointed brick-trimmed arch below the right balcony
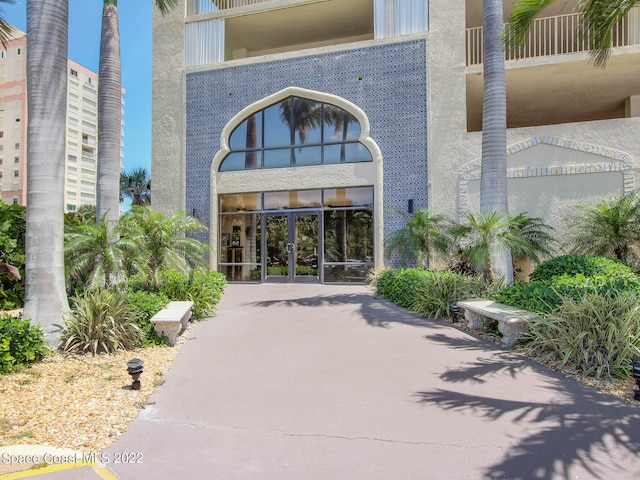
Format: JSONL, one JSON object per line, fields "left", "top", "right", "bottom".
{"left": 457, "top": 118, "right": 640, "bottom": 248}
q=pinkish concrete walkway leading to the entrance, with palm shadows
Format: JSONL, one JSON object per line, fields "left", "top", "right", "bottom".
{"left": 15, "top": 285, "right": 640, "bottom": 480}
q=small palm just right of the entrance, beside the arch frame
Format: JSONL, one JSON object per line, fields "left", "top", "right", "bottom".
{"left": 385, "top": 209, "right": 452, "bottom": 267}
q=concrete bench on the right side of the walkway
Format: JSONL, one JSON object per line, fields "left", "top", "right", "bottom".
{"left": 457, "top": 300, "right": 540, "bottom": 347}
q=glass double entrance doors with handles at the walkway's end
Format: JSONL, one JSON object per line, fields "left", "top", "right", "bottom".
{"left": 265, "top": 212, "right": 320, "bottom": 283}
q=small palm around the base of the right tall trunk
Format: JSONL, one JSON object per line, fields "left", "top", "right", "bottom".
{"left": 450, "top": 211, "right": 553, "bottom": 283}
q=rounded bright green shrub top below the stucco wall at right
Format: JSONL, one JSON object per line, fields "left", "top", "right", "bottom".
{"left": 529, "top": 255, "right": 637, "bottom": 280}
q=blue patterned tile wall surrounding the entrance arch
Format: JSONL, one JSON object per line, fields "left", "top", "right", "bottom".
{"left": 186, "top": 40, "right": 427, "bottom": 248}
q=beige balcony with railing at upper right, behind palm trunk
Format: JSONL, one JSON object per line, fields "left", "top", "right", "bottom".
{"left": 466, "top": 6, "right": 640, "bottom": 131}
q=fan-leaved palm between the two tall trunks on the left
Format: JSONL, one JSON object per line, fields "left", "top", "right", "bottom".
{"left": 65, "top": 216, "right": 143, "bottom": 288}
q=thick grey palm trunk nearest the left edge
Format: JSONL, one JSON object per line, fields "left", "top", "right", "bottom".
{"left": 23, "top": 0, "right": 69, "bottom": 347}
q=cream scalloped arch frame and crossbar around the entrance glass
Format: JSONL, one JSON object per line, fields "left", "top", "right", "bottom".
{"left": 209, "top": 87, "right": 384, "bottom": 278}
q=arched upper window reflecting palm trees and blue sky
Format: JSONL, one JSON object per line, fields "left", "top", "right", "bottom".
{"left": 220, "top": 96, "right": 373, "bottom": 172}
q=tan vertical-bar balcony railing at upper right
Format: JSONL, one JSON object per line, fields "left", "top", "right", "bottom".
{"left": 467, "top": 7, "right": 640, "bottom": 65}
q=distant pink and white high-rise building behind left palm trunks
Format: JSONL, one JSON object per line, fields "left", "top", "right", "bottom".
{"left": 0, "top": 30, "right": 124, "bottom": 212}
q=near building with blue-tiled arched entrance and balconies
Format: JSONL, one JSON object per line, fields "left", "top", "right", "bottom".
{"left": 153, "top": 0, "right": 640, "bottom": 282}
